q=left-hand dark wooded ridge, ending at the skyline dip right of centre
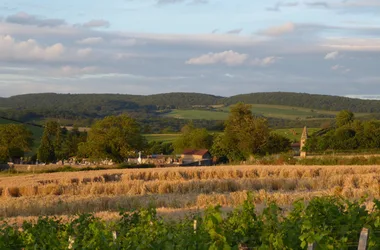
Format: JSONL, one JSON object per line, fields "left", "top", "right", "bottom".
{"left": 0, "top": 93, "right": 222, "bottom": 112}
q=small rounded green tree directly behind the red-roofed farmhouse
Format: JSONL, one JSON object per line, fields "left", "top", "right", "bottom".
{"left": 173, "top": 123, "right": 213, "bottom": 153}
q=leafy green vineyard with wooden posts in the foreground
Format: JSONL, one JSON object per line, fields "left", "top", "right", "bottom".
{"left": 0, "top": 195, "right": 380, "bottom": 250}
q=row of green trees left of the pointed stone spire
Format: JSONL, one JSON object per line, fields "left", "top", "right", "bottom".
{"left": 0, "top": 103, "right": 290, "bottom": 163}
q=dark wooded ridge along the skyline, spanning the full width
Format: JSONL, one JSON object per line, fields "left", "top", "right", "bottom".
{"left": 0, "top": 92, "right": 380, "bottom": 115}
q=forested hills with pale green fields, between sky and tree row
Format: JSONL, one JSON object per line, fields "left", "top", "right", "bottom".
{"left": 0, "top": 92, "right": 380, "bottom": 133}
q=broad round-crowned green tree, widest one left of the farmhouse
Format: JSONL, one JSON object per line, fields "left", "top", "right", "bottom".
{"left": 79, "top": 115, "right": 146, "bottom": 162}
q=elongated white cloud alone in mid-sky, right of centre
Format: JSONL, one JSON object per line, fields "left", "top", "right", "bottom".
{"left": 186, "top": 50, "right": 248, "bottom": 66}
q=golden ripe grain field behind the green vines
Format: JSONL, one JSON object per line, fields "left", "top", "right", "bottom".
{"left": 0, "top": 166, "right": 380, "bottom": 218}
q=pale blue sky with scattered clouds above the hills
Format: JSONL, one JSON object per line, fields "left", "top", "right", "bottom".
{"left": 0, "top": 0, "right": 380, "bottom": 97}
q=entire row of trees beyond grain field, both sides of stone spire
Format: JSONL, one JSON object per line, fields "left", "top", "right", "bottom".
{"left": 0, "top": 103, "right": 380, "bottom": 163}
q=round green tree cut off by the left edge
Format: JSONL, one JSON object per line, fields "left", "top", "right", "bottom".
{"left": 0, "top": 124, "right": 33, "bottom": 162}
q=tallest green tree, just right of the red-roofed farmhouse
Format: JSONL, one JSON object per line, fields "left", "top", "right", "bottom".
{"left": 223, "top": 103, "right": 270, "bottom": 161}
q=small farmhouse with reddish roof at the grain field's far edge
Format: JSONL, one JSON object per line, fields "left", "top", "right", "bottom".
{"left": 181, "top": 149, "right": 212, "bottom": 166}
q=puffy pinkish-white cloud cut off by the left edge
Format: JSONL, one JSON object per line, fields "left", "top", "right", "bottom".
{"left": 0, "top": 35, "right": 65, "bottom": 61}
